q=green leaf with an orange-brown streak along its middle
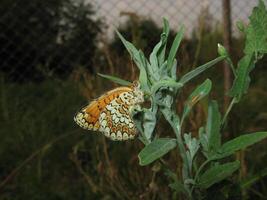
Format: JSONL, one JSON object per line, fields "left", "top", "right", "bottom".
{"left": 182, "top": 79, "right": 212, "bottom": 121}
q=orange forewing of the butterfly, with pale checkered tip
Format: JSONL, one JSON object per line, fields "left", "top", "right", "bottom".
{"left": 74, "top": 87, "right": 132, "bottom": 131}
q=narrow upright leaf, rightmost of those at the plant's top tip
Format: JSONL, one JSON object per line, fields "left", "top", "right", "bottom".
{"left": 167, "top": 26, "right": 184, "bottom": 71}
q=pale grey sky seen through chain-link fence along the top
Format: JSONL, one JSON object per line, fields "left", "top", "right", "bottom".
{"left": 93, "top": 0, "right": 258, "bottom": 35}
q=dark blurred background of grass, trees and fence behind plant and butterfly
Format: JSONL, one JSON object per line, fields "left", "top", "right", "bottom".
{"left": 0, "top": 0, "right": 267, "bottom": 200}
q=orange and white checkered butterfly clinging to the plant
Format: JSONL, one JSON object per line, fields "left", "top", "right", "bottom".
{"left": 74, "top": 82, "right": 144, "bottom": 141}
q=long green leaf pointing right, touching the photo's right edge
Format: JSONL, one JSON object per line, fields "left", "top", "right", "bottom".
{"left": 215, "top": 132, "right": 267, "bottom": 160}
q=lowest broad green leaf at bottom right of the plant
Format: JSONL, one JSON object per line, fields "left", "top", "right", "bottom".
{"left": 197, "top": 161, "right": 240, "bottom": 189}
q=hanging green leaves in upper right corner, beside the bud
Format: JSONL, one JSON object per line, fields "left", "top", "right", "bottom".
{"left": 228, "top": 0, "right": 267, "bottom": 102}
